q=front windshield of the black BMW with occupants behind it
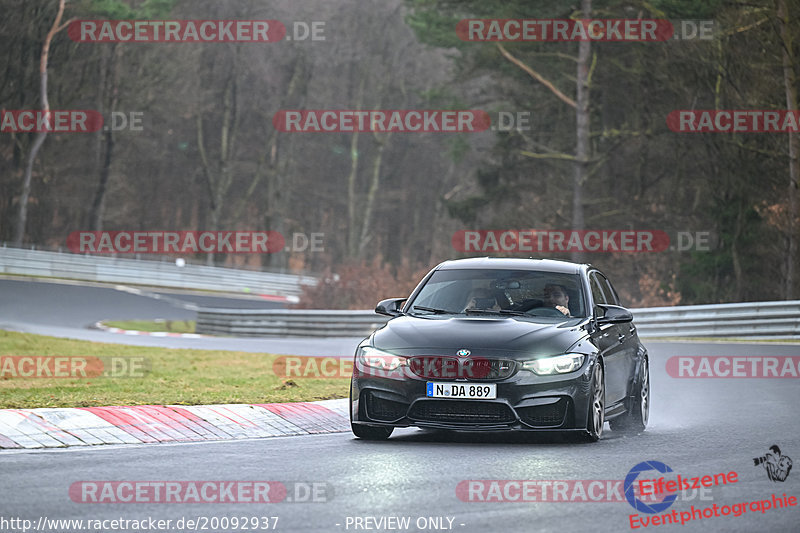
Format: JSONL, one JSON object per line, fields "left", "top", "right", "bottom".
{"left": 407, "top": 269, "right": 586, "bottom": 318}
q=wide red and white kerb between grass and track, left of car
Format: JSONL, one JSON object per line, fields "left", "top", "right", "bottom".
{"left": 0, "top": 399, "right": 350, "bottom": 449}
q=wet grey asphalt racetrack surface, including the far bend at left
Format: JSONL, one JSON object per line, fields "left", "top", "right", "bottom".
{"left": 0, "top": 281, "right": 800, "bottom": 533}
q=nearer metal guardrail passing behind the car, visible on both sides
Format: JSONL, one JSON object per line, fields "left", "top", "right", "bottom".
{"left": 197, "top": 301, "right": 800, "bottom": 338}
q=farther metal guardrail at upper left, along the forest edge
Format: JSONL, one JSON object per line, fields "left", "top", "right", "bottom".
{"left": 0, "top": 247, "right": 317, "bottom": 300}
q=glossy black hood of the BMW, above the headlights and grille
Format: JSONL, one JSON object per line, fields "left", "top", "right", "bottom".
{"left": 373, "top": 316, "right": 586, "bottom": 356}
